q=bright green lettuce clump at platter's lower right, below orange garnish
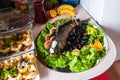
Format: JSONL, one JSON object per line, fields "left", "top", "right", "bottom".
{"left": 69, "top": 46, "right": 105, "bottom": 72}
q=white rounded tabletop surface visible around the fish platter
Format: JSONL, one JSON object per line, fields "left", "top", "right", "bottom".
{"left": 33, "top": 5, "right": 116, "bottom": 80}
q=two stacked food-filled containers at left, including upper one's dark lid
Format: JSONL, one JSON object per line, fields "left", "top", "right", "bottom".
{"left": 0, "top": 9, "right": 40, "bottom": 80}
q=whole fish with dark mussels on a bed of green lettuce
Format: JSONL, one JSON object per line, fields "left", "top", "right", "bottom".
{"left": 36, "top": 18, "right": 107, "bottom": 72}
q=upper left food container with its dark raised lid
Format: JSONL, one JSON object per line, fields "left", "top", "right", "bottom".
{"left": 0, "top": 15, "right": 34, "bottom": 60}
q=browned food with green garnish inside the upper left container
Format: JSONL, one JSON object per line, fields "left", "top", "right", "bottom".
{"left": 0, "top": 30, "right": 32, "bottom": 56}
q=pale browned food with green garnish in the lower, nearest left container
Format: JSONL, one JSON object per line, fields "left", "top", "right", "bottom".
{"left": 0, "top": 51, "right": 38, "bottom": 80}
